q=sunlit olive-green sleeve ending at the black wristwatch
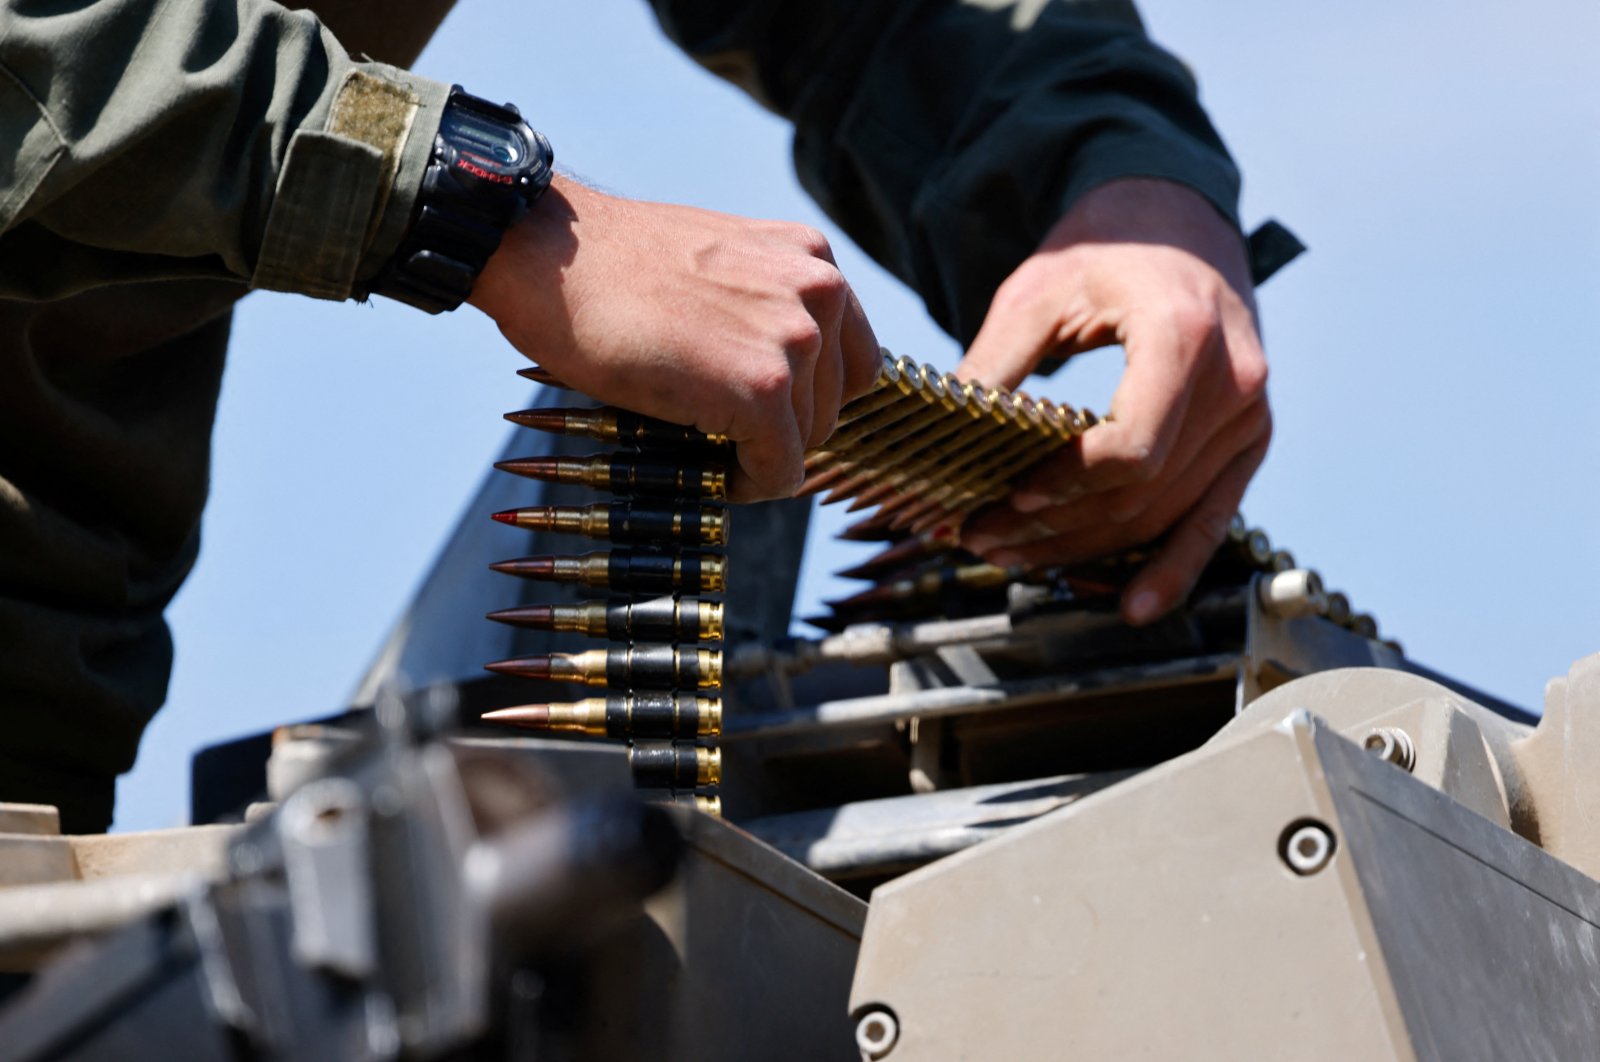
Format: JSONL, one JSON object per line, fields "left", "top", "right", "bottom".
{"left": 0, "top": 0, "right": 448, "bottom": 299}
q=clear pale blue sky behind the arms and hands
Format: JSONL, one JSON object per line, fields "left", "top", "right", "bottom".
{"left": 117, "top": 0, "right": 1600, "bottom": 828}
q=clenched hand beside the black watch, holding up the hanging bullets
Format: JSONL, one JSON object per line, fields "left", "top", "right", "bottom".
{"left": 470, "top": 178, "right": 880, "bottom": 501}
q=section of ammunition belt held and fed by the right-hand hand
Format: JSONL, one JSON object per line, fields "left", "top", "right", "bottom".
{"left": 800, "top": 353, "right": 1398, "bottom": 648}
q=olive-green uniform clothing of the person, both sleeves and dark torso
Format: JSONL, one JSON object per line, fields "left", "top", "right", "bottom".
{"left": 0, "top": 0, "right": 1237, "bottom": 832}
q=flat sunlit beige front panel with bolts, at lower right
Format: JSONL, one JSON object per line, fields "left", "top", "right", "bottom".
{"left": 851, "top": 717, "right": 1413, "bottom": 1062}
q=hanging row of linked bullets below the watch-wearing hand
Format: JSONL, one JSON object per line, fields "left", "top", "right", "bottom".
{"left": 483, "top": 368, "right": 731, "bottom": 814}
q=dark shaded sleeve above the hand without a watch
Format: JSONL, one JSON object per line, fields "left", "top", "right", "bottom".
{"left": 653, "top": 0, "right": 1238, "bottom": 342}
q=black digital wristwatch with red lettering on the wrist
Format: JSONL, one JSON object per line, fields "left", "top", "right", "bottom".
{"left": 371, "top": 85, "right": 555, "bottom": 313}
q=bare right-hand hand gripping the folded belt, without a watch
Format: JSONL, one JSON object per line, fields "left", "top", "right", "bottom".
{"left": 957, "top": 179, "right": 1272, "bottom": 624}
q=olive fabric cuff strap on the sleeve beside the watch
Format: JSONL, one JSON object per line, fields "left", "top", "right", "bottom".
{"left": 250, "top": 130, "right": 390, "bottom": 301}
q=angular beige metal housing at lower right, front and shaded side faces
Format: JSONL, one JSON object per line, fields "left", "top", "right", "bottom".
{"left": 851, "top": 694, "right": 1600, "bottom": 1060}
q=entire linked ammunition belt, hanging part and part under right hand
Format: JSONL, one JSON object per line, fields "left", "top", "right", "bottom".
{"left": 485, "top": 353, "right": 1398, "bottom": 786}
